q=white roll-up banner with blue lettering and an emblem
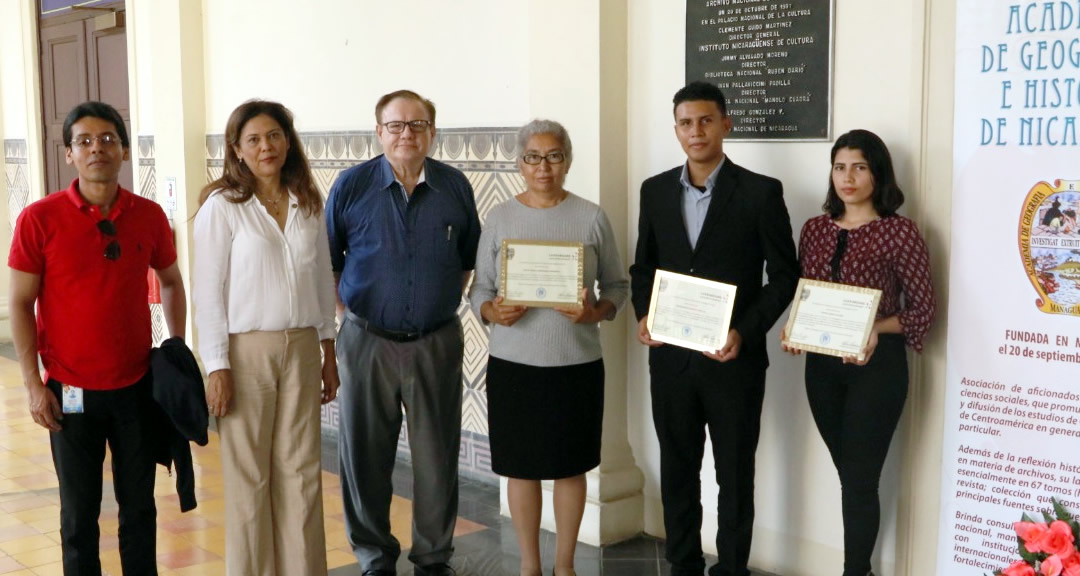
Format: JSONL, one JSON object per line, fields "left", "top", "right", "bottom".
{"left": 937, "top": 0, "right": 1080, "bottom": 576}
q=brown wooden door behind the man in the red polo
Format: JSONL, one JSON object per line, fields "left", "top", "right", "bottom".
{"left": 40, "top": 4, "right": 131, "bottom": 192}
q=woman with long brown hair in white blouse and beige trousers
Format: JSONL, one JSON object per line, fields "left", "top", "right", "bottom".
{"left": 192, "top": 101, "right": 338, "bottom": 576}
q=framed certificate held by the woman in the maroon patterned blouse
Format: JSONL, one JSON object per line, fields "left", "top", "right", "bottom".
{"left": 784, "top": 278, "right": 881, "bottom": 360}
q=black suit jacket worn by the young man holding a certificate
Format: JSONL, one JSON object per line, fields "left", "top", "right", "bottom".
{"left": 630, "top": 158, "right": 799, "bottom": 375}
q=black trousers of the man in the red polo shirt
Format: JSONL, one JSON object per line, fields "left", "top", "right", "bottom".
{"left": 48, "top": 375, "right": 158, "bottom": 576}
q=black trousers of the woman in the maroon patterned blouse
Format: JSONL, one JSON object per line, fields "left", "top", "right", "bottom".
{"left": 806, "top": 334, "right": 907, "bottom": 576}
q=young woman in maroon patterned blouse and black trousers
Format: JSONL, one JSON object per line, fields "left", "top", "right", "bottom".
{"left": 781, "top": 130, "right": 934, "bottom": 576}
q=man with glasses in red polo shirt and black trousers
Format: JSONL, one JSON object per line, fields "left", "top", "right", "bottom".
{"left": 8, "top": 102, "right": 187, "bottom": 576}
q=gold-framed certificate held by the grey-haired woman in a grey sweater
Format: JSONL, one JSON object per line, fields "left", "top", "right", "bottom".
{"left": 499, "top": 240, "right": 585, "bottom": 308}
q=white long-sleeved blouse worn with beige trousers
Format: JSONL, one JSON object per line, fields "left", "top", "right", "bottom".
{"left": 191, "top": 190, "right": 336, "bottom": 374}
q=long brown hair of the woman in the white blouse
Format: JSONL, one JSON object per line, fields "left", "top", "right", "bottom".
{"left": 199, "top": 99, "right": 323, "bottom": 216}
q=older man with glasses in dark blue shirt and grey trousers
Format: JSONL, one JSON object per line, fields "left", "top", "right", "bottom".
{"left": 326, "top": 91, "right": 480, "bottom": 576}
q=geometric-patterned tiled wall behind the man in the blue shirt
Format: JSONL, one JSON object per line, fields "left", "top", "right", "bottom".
{"left": 208, "top": 128, "right": 524, "bottom": 482}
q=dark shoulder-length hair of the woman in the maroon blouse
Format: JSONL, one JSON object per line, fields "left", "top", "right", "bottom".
{"left": 821, "top": 130, "right": 904, "bottom": 219}
